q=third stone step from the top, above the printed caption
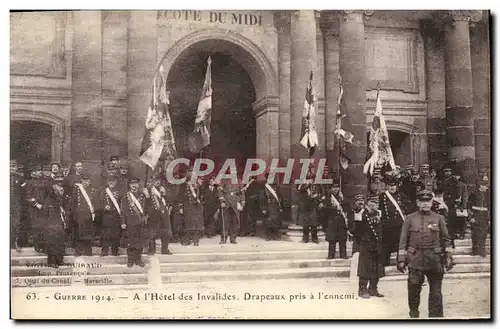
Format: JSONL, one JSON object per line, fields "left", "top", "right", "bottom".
{"left": 11, "top": 255, "right": 491, "bottom": 277}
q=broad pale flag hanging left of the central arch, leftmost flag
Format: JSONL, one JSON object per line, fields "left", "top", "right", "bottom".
{"left": 139, "top": 66, "right": 177, "bottom": 171}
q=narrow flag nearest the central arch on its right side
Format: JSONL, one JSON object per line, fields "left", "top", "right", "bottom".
{"left": 300, "top": 71, "right": 319, "bottom": 156}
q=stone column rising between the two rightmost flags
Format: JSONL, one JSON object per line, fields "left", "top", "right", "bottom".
{"left": 339, "top": 11, "right": 372, "bottom": 198}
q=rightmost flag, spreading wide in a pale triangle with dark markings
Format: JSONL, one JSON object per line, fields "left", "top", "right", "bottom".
{"left": 363, "top": 92, "right": 396, "bottom": 176}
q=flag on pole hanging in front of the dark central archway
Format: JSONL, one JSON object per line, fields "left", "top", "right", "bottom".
{"left": 188, "top": 57, "right": 212, "bottom": 154}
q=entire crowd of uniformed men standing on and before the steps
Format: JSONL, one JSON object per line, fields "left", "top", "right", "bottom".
{"left": 11, "top": 156, "right": 490, "bottom": 317}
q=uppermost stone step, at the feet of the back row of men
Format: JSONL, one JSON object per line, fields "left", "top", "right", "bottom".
{"left": 10, "top": 238, "right": 490, "bottom": 258}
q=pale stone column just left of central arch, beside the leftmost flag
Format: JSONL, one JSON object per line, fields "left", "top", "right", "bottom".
{"left": 127, "top": 11, "right": 158, "bottom": 179}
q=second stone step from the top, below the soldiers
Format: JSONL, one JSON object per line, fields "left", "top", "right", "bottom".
{"left": 11, "top": 246, "right": 490, "bottom": 266}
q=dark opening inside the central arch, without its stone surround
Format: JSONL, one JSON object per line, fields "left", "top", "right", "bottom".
{"left": 167, "top": 40, "right": 256, "bottom": 169}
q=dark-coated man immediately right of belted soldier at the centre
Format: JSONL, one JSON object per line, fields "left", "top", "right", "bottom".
{"left": 240, "top": 177, "right": 262, "bottom": 236}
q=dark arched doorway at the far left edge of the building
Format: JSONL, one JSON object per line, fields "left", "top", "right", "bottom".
{"left": 10, "top": 120, "right": 53, "bottom": 171}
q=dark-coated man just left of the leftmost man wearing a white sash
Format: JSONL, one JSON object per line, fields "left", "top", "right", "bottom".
{"left": 40, "top": 173, "right": 68, "bottom": 268}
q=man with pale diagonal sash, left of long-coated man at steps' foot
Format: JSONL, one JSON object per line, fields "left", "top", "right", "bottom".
{"left": 322, "top": 181, "right": 348, "bottom": 259}
